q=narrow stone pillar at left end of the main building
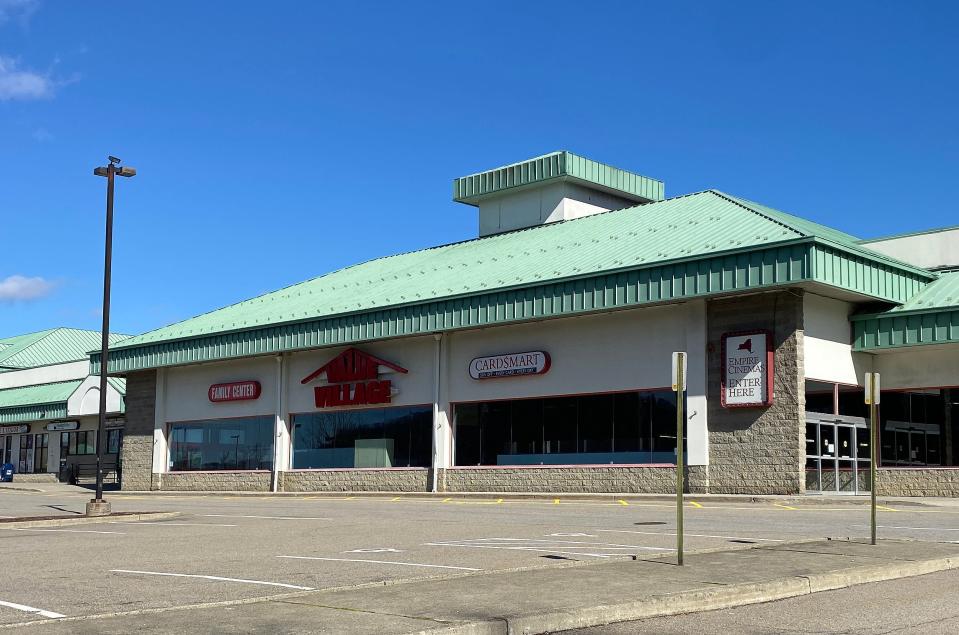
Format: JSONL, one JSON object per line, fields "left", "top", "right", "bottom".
{"left": 120, "top": 370, "right": 156, "bottom": 491}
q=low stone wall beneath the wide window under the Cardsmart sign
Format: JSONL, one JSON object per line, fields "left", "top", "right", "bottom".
{"left": 446, "top": 465, "right": 705, "bottom": 494}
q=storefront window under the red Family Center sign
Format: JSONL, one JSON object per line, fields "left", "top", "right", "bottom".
{"left": 170, "top": 417, "right": 273, "bottom": 472}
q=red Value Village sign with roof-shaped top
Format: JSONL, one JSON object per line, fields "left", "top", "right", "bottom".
{"left": 300, "top": 348, "right": 408, "bottom": 408}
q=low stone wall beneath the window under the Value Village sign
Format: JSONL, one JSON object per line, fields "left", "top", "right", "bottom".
{"left": 279, "top": 468, "right": 429, "bottom": 492}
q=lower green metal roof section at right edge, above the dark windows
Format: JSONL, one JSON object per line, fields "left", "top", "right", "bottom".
{"left": 850, "top": 271, "right": 959, "bottom": 351}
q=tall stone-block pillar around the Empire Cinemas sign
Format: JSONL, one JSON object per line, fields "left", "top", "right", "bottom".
{"left": 706, "top": 290, "right": 806, "bottom": 494}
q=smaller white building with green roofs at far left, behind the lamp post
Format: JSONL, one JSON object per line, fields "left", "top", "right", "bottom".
{"left": 0, "top": 328, "right": 129, "bottom": 482}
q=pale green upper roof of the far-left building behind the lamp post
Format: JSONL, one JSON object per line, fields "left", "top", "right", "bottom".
{"left": 0, "top": 328, "right": 130, "bottom": 372}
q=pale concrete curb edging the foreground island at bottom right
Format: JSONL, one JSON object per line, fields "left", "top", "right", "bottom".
{"left": 416, "top": 557, "right": 959, "bottom": 635}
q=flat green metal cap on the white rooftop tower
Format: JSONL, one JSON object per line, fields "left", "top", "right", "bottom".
{"left": 453, "top": 150, "right": 664, "bottom": 205}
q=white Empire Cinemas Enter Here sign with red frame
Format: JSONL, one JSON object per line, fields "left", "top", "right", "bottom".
{"left": 722, "top": 331, "right": 773, "bottom": 408}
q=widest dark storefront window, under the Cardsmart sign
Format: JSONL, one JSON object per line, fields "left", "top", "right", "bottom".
{"left": 455, "top": 391, "right": 676, "bottom": 465}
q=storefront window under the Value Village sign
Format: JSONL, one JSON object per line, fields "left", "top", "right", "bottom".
{"left": 293, "top": 406, "right": 433, "bottom": 469}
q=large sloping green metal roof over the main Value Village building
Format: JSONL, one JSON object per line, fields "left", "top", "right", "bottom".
{"left": 93, "top": 190, "right": 935, "bottom": 372}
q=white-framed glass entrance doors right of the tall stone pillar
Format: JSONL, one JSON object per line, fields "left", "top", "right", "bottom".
{"left": 806, "top": 412, "right": 869, "bottom": 494}
